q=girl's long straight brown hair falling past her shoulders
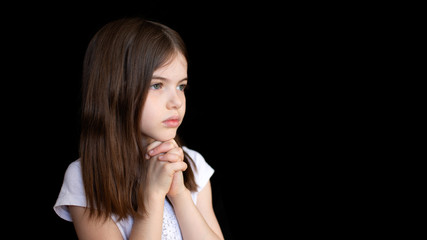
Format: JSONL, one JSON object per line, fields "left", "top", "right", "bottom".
{"left": 80, "top": 18, "right": 197, "bottom": 219}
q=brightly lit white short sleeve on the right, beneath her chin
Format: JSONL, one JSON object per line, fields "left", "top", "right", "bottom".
{"left": 183, "top": 147, "right": 214, "bottom": 203}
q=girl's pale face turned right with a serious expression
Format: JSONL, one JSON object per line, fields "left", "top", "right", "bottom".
{"left": 140, "top": 53, "right": 187, "bottom": 141}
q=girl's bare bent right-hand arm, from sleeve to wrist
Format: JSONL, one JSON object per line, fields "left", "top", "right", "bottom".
{"left": 169, "top": 182, "right": 224, "bottom": 240}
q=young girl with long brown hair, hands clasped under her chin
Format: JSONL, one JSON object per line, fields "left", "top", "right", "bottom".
{"left": 54, "top": 18, "right": 223, "bottom": 240}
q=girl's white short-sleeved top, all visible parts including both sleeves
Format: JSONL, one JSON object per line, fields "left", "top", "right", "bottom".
{"left": 53, "top": 147, "right": 214, "bottom": 240}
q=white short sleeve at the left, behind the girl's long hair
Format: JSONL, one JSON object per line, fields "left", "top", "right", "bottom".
{"left": 53, "top": 160, "right": 86, "bottom": 222}
